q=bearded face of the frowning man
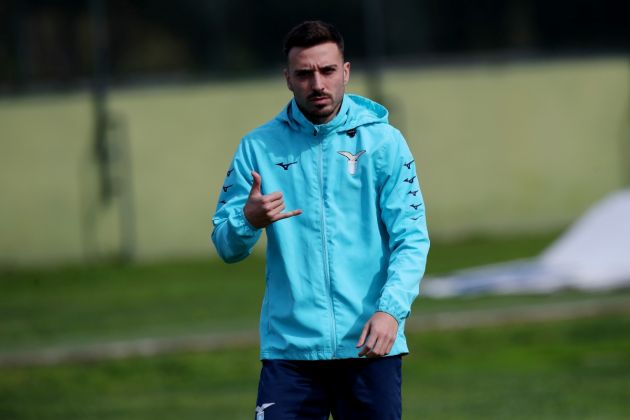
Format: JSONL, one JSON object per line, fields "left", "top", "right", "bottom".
{"left": 284, "top": 42, "right": 350, "bottom": 124}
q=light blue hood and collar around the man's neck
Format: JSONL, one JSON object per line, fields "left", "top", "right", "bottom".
{"left": 276, "top": 94, "right": 389, "bottom": 134}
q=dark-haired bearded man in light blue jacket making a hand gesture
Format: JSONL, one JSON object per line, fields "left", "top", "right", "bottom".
{"left": 212, "top": 21, "right": 429, "bottom": 420}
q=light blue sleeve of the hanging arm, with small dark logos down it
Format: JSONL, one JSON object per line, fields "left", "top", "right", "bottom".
{"left": 377, "top": 130, "right": 429, "bottom": 323}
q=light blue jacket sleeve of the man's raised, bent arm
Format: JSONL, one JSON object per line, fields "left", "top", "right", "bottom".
{"left": 211, "top": 141, "right": 262, "bottom": 263}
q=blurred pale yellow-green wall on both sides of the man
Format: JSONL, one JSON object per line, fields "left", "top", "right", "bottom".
{"left": 0, "top": 59, "right": 630, "bottom": 266}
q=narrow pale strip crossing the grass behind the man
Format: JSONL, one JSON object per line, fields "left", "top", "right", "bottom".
{"left": 0, "top": 295, "right": 630, "bottom": 368}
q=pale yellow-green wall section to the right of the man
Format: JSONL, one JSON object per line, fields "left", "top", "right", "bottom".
{"left": 388, "top": 60, "right": 630, "bottom": 235}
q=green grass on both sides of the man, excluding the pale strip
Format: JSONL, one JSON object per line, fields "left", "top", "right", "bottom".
{"left": 0, "top": 234, "right": 630, "bottom": 420}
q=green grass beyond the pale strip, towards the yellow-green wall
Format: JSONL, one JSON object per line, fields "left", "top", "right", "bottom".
{"left": 0, "top": 234, "right": 554, "bottom": 352}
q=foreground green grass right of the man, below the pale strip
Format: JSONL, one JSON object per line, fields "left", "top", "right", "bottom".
{"left": 405, "top": 315, "right": 630, "bottom": 419}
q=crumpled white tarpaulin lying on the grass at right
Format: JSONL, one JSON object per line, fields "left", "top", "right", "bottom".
{"left": 421, "top": 190, "right": 630, "bottom": 297}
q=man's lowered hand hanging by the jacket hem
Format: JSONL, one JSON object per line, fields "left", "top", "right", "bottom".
{"left": 357, "top": 312, "right": 398, "bottom": 357}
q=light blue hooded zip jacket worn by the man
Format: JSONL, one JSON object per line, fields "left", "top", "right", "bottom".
{"left": 212, "top": 95, "right": 429, "bottom": 360}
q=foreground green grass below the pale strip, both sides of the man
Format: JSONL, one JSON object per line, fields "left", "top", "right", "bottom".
{"left": 0, "top": 315, "right": 630, "bottom": 420}
